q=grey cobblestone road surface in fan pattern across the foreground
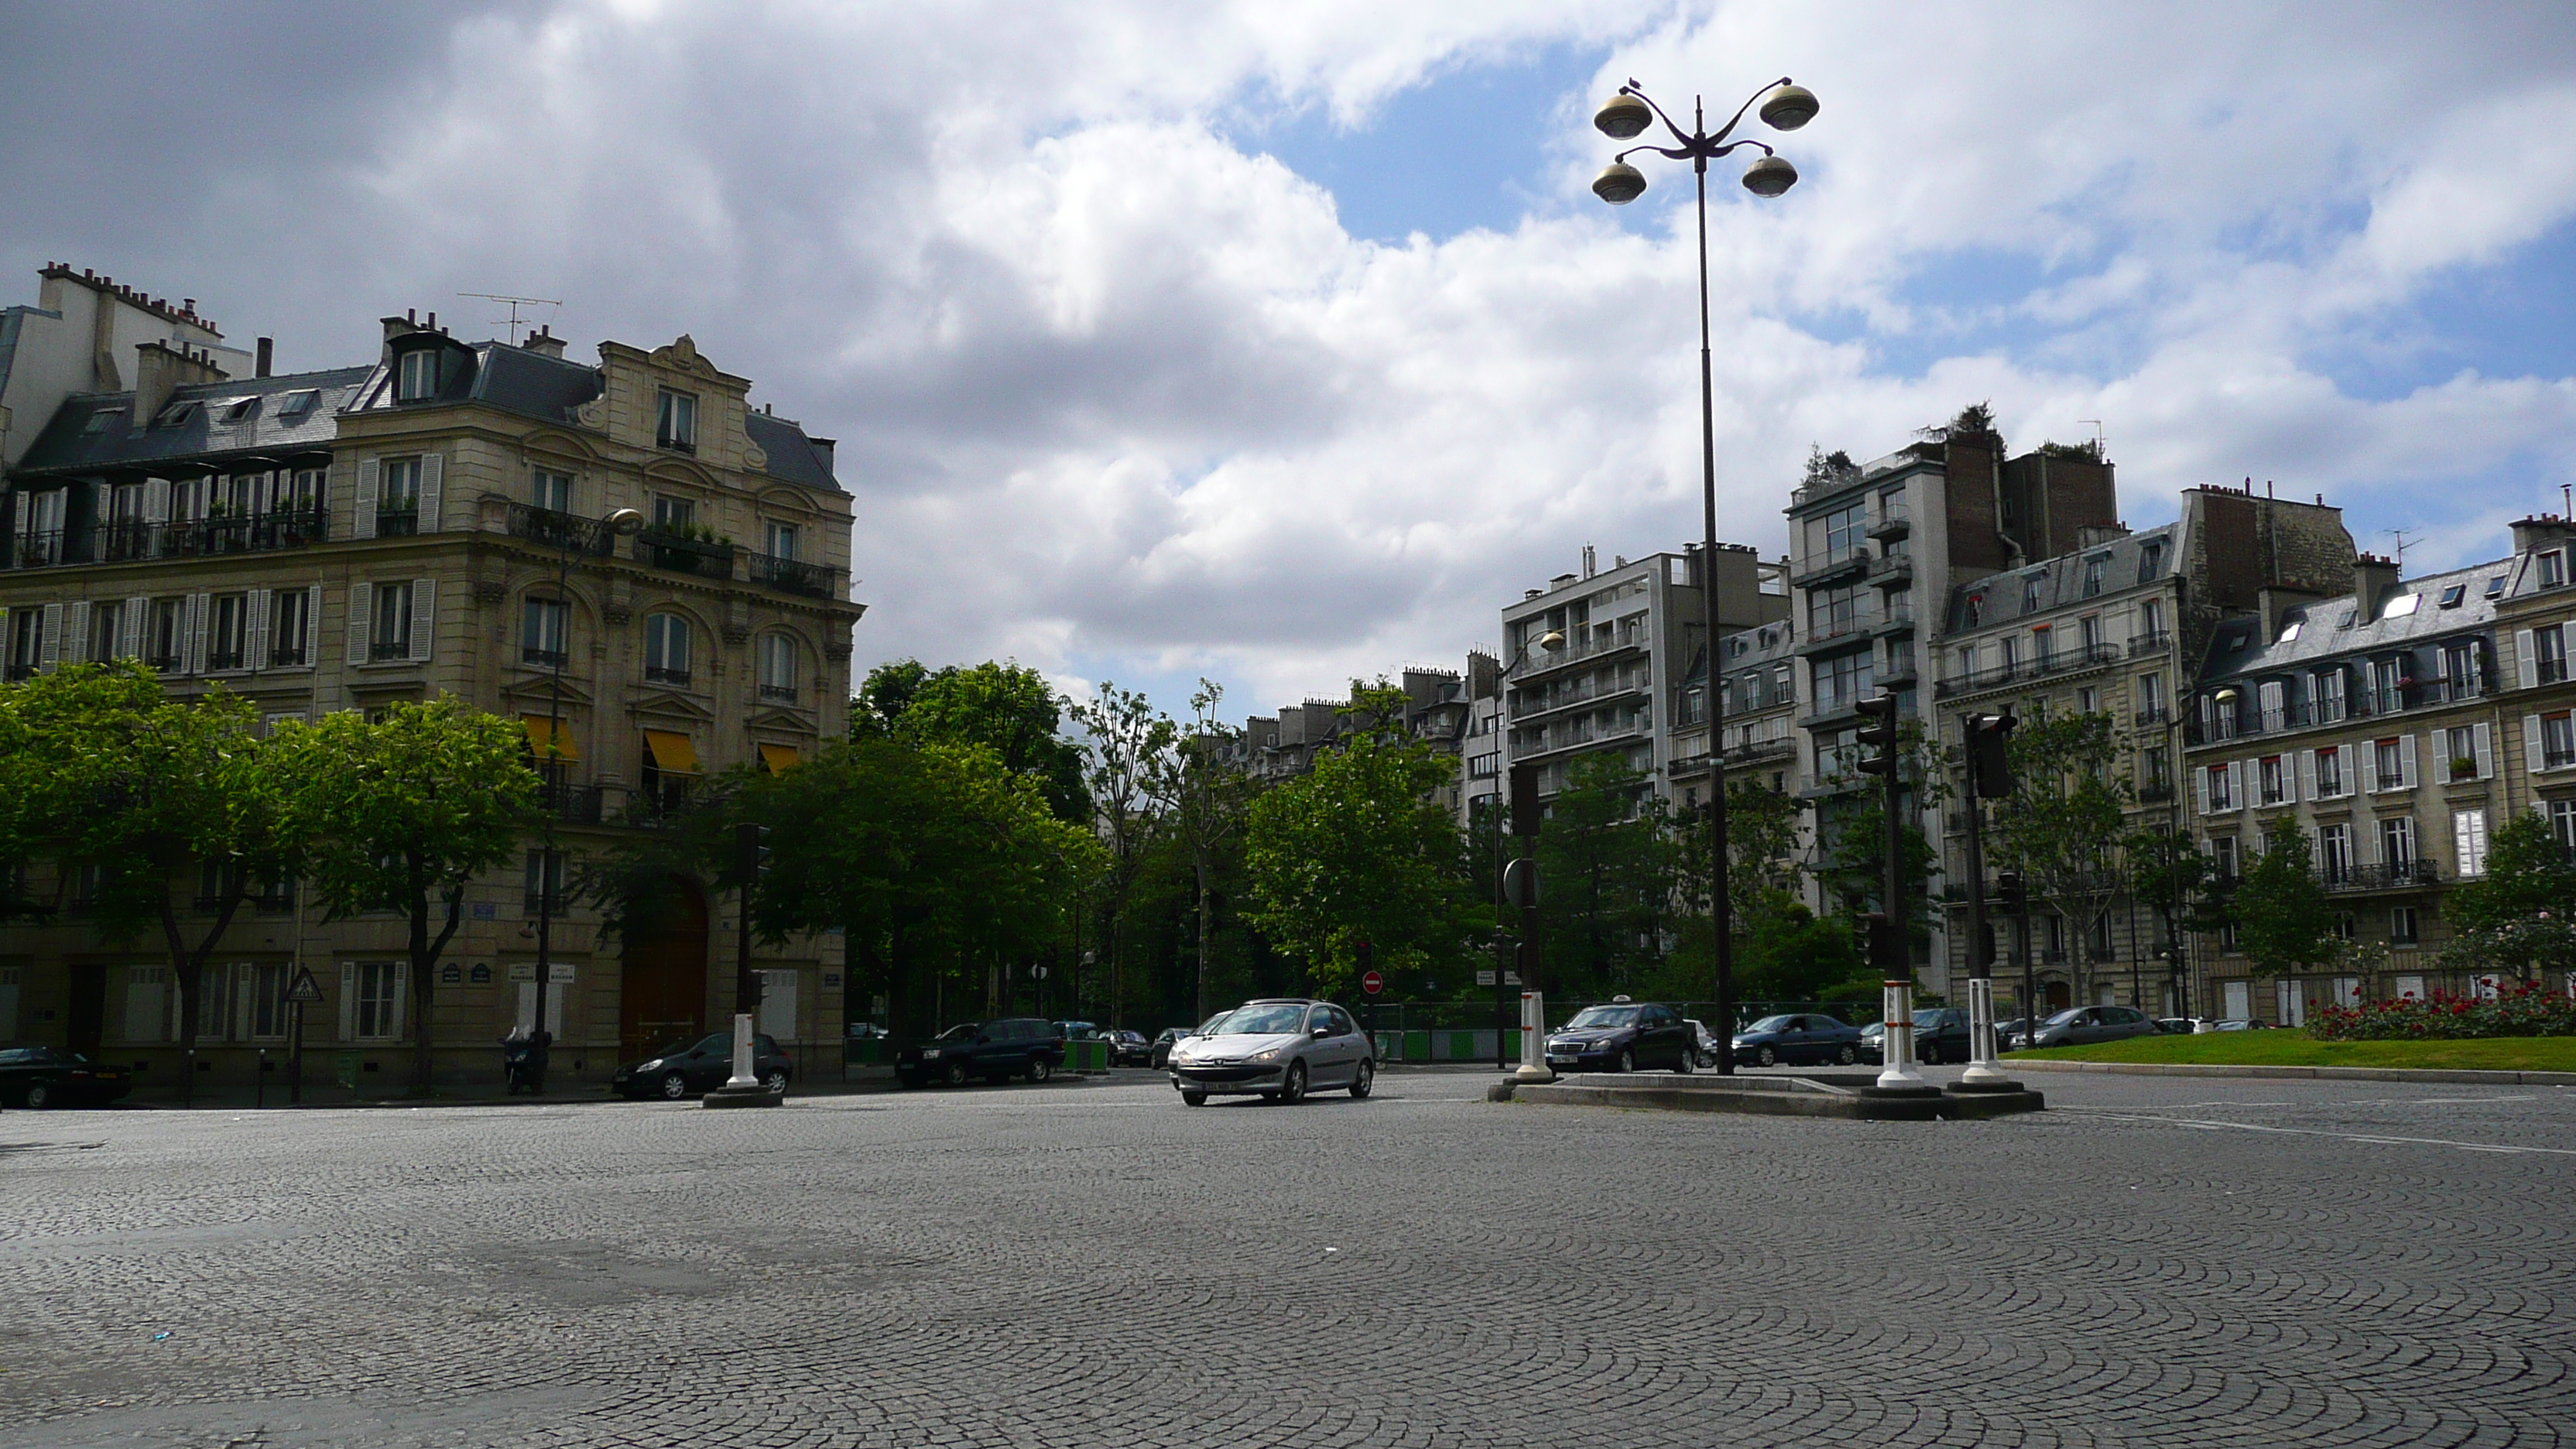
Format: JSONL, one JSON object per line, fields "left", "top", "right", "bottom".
{"left": 0, "top": 1073, "right": 2576, "bottom": 1449}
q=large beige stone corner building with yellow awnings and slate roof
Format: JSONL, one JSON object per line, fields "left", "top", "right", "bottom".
{"left": 0, "top": 268, "right": 861, "bottom": 1083}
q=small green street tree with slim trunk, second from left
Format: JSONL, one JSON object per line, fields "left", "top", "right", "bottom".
{"left": 273, "top": 696, "right": 539, "bottom": 1093}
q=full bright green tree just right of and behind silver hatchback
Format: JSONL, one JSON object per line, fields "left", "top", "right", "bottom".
{"left": 1244, "top": 686, "right": 1476, "bottom": 992}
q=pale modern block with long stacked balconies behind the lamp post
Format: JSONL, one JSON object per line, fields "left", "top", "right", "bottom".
{"left": 1497, "top": 544, "right": 1788, "bottom": 800}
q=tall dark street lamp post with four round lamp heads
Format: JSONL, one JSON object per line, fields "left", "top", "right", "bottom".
{"left": 1592, "top": 75, "right": 1816, "bottom": 1073}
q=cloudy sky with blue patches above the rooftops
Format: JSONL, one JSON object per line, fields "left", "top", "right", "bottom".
{"left": 0, "top": 0, "right": 2576, "bottom": 711}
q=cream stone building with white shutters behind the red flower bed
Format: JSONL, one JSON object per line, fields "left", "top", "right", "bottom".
{"left": 2187, "top": 519, "right": 2576, "bottom": 1026}
